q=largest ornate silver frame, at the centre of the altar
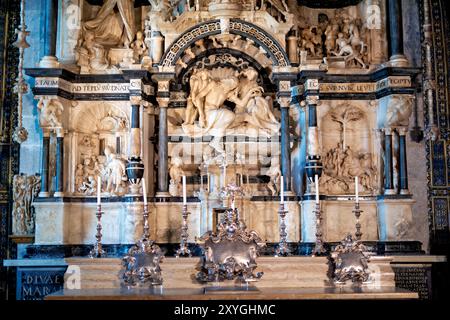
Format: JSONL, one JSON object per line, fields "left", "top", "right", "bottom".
{"left": 196, "top": 204, "right": 266, "bottom": 283}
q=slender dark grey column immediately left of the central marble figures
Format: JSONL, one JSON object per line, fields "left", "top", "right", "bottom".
{"left": 156, "top": 98, "right": 169, "bottom": 197}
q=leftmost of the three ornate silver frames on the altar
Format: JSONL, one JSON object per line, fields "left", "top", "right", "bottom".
{"left": 122, "top": 238, "right": 164, "bottom": 286}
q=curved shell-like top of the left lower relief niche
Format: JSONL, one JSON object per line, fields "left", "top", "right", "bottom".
{"left": 74, "top": 102, "right": 129, "bottom": 134}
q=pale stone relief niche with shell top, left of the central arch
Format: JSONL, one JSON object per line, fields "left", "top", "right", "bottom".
{"left": 68, "top": 101, "right": 130, "bottom": 196}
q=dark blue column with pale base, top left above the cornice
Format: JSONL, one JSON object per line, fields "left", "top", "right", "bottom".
{"left": 39, "top": 0, "right": 59, "bottom": 68}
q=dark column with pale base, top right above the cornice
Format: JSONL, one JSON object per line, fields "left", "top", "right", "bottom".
{"left": 386, "top": 0, "right": 408, "bottom": 67}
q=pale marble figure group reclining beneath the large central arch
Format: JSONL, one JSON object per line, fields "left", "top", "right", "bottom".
{"left": 182, "top": 67, "right": 280, "bottom": 153}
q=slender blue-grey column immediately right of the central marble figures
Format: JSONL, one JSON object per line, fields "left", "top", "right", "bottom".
{"left": 278, "top": 97, "right": 291, "bottom": 192}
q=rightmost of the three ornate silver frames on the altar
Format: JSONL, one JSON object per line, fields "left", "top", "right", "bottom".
{"left": 331, "top": 234, "right": 370, "bottom": 284}
